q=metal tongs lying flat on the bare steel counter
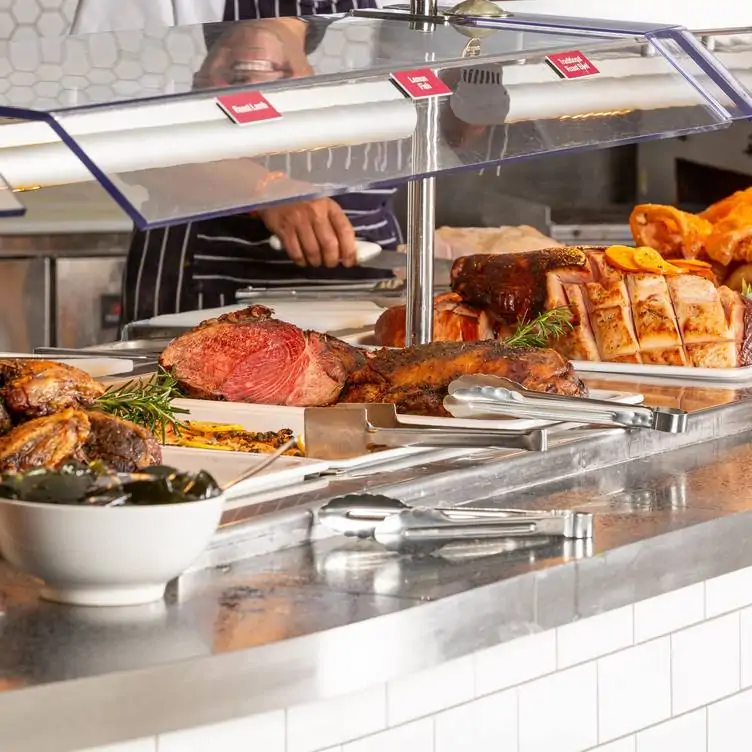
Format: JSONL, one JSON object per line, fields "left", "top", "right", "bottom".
{"left": 318, "top": 494, "right": 593, "bottom": 551}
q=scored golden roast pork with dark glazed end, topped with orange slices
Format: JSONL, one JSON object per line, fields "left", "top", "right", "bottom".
{"left": 452, "top": 248, "right": 752, "bottom": 368}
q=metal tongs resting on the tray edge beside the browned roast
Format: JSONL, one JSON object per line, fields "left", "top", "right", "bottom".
{"left": 444, "top": 376, "right": 687, "bottom": 433}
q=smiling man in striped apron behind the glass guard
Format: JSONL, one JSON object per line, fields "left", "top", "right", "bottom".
{"left": 123, "top": 0, "right": 402, "bottom": 323}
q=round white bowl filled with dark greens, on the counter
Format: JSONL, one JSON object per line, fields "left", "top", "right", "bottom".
{"left": 0, "top": 495, "right": 224, "bottom": 606}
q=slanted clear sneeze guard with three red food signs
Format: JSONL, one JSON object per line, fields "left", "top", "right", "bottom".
{"left": 0, "top": 17, "right": 752, "bottom": 228}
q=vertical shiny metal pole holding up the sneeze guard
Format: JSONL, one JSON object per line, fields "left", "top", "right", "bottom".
{"left": 405, "top": 0, "right": 439, "bottom": 347}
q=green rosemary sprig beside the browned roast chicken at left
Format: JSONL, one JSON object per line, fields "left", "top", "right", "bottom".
{"left": 97, "top": 368, "right": 188, "bottom": 443}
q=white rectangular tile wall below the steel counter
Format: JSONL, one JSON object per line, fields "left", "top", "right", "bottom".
{"left": 76, "top": 568, "right": 752, "bottom": 752}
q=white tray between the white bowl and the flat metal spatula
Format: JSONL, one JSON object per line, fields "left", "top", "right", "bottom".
{"left": 162, "top": 446, "right": 329, "bottom": 501}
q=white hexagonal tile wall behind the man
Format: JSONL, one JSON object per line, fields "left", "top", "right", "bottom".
{"left": 0, "top": 0, "right": 374, "bottom": 108}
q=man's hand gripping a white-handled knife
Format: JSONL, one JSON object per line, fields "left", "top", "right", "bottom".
{"left": 257, "top": 198, "right": 356, "bottom": 267}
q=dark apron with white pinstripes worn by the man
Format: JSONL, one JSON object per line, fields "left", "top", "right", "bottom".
{"left": 123, "top": 0, "right": 402, "bottom": 323}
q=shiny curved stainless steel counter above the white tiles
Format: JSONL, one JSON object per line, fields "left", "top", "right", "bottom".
{"left": 0, "top": 390, "right": 752, "bottom": 752}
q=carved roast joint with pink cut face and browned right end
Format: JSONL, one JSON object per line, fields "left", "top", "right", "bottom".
{"left": 160, "top": 305, "right": 585, "bottom": 415}
